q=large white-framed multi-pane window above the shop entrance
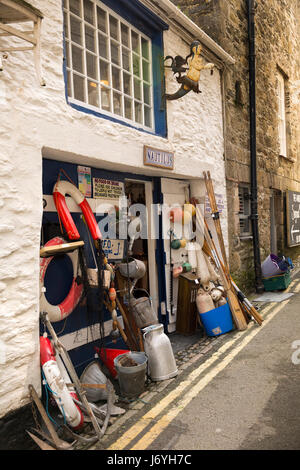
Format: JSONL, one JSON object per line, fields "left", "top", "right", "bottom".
{"left": 64, "top": 0, "right": 154, "bottom": 131}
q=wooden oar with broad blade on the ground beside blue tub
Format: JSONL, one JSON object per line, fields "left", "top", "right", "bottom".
{"left": 196, "top": 207, "right": 247, "bottom": 331}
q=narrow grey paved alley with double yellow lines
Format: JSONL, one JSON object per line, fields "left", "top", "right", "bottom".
{"left": 90, "top": 272, "right": 300, "bottom": 452}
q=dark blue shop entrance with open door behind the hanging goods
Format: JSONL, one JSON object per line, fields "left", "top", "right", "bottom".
{"left": 40, "top": 158, "right": 211, "bottom": 373}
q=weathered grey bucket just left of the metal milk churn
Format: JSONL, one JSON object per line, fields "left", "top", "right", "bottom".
{"left": 114, "top": 352, "right": 147, "bottom": 398}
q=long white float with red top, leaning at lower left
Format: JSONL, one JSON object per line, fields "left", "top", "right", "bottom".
{"left": 40, "top": 336, "right": 84, "bottom": 429}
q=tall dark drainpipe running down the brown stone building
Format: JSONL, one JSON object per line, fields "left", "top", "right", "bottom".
{"left": 247, "top": 0, "right": 264, "bottom": 292}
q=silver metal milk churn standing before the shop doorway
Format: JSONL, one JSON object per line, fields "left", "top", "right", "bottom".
{"left": 142, "top": 323, "right": 178, "bottom": 381}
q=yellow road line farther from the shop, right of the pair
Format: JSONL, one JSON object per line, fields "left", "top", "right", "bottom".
{"left": 130, "top": 300, "right": 289, "bottom": 450}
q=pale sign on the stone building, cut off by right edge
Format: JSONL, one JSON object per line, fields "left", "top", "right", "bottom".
{"left": 286, "top": 191, "right": 300, "bottom": 246}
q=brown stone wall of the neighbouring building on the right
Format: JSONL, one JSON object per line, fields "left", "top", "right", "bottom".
{"left": 174, "top": 0, "right": 300, "bottom": 290}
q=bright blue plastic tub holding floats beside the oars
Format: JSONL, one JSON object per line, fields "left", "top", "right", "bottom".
{"left": 199, "top": 303, "right": 233, "bottom": 336}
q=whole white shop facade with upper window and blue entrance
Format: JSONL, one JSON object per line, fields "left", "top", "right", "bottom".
{"left": 0, "top": 0, "right": 234, "bottom": 448}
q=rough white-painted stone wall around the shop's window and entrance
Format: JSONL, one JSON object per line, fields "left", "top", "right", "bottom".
{"left": 0, "top": 0, "right": 227, "bottom": 417}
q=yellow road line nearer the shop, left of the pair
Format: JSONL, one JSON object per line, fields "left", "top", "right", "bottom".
{"left": 108, "top": 302, "right": 276, "bottom": 450}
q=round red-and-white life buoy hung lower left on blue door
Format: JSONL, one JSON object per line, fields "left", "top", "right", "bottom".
{"left": 40, "top": 237, "right": 83, "bottom": 322}
